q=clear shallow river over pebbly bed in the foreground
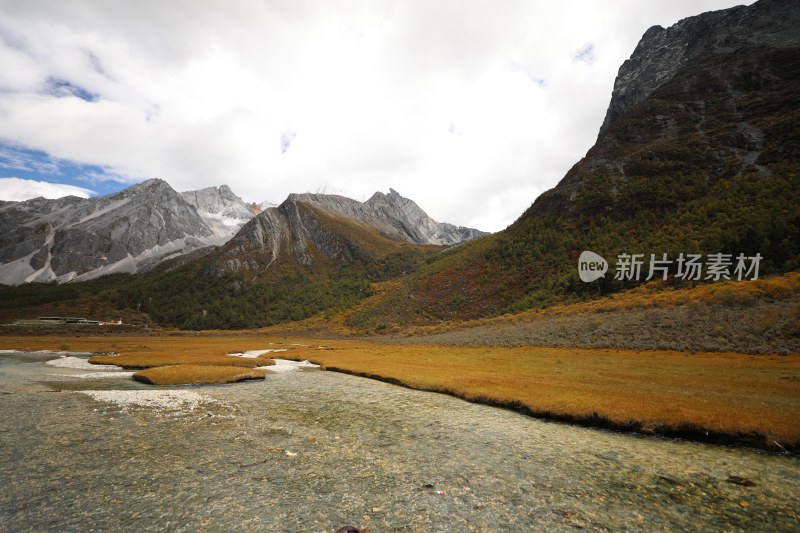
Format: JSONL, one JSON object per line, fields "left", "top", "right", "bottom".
{"left": 0, "top": 353, "right": 800, "bottom": 532}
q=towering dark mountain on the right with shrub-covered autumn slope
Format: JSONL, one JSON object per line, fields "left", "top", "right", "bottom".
{"left": 350, "top": 0, "right": 800, "bottom": 328}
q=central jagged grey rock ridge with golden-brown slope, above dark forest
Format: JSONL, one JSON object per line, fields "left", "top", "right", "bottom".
{"left": 217, "top": 190, "right": 487, "bottom": 273}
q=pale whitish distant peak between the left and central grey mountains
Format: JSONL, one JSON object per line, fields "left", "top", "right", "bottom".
{"left": 181, "top": 185, "right": 257, "bottom": 244}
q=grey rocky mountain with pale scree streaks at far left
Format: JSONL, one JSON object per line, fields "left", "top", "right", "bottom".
{"left": 0, "top": 179, "right": 214, "bottom": 284}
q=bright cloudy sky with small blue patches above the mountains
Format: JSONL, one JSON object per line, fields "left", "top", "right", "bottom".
{"left": 0, "top": 0, "right": 751, "bottom": 231}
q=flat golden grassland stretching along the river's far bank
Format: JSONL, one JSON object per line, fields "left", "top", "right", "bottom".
{"left": 0, "top": 333, "right": 800, "bottom": 449}
